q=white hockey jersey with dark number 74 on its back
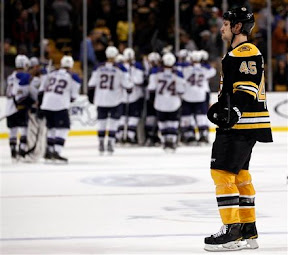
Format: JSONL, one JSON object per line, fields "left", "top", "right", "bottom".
{"left": 148, "top": 68, "right": 185, "bottom": 112}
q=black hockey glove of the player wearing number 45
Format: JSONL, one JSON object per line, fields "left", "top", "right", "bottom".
{"left": 207, "top": 102, "right": 241, "bottom": 128}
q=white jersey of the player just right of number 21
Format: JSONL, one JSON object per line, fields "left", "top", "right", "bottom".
{"left": 123, "top": 62, "right": 144, "bottom": 103}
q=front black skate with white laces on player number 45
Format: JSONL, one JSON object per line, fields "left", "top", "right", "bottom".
{"left": 204, "top": 223, "right": 243, "bottom": 251}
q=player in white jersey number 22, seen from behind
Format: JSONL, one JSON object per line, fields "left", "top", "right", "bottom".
{"left": 39, "top": 56, "right": 81, "bottom": 163}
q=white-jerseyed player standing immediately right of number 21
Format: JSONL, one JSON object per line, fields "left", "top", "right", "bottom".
{"left": 118, "top": 48, "right": 144, "bottom": 144}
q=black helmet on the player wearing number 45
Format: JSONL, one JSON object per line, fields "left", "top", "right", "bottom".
{"left": 223, "top": 7, "right": 255, "bottom": 35}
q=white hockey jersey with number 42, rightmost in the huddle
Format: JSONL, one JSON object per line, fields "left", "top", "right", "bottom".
{"left": 182, "top": 63, "right": 216, "bottom": 103}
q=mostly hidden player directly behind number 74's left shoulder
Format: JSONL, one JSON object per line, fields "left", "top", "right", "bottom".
{"left": 145, "top": 52, "right": 161, "bottom": 146}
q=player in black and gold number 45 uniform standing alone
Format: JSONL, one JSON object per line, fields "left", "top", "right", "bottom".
{"left": 205, "top": 7, "right": 272, "bottom": 251}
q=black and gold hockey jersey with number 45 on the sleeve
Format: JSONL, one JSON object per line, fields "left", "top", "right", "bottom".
{"left": 218, "top": 42, "right": 272, "bottom": 142}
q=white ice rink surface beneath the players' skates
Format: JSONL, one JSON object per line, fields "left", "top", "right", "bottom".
{"left": 0, "top": 133, "right": 288, "bottom": 255}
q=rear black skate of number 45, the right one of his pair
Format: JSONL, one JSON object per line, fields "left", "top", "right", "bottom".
{"left": 241, "top": 222, "right": 259, "bottom": 249}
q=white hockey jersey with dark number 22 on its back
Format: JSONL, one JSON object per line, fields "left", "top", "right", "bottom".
{"left": 40, "top": 68, "right": 80, "bottom": 111}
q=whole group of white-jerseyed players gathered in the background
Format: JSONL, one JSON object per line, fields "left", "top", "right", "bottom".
{"left": 6, "top": 46, "right": 216, "bottom": 162}
